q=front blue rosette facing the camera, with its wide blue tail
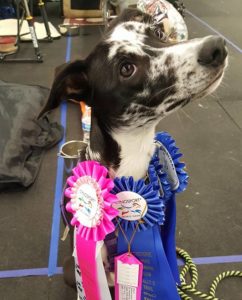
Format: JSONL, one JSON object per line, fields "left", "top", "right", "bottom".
{"left": 113, "top": 176, "right": 180, "bottom": 300}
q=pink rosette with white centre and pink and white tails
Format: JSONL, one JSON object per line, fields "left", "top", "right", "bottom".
{"left": 65, "top": 161, "right": 118, "bottom": 300}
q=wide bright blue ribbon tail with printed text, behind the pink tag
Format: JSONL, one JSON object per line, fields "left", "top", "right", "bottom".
{"left": 118, "top": 225, "right": 180, "bottom": 300}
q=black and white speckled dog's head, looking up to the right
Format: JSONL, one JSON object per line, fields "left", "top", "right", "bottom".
{"left": 42, "top": 10, "right": 227, "bottom": 128}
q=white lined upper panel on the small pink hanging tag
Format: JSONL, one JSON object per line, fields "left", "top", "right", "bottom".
{"left": 117, "top": 261, "right": 139, "bottom": 287}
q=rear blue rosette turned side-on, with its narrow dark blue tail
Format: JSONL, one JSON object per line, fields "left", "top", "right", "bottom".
{"left": 149, "top": 132, "right": 188, "bottom": 284}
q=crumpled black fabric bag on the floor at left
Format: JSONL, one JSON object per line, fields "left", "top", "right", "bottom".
{"left": 0, "top": 81, "right": 63, "bottom": 191}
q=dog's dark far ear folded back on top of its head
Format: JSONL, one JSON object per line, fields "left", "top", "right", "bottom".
{"left": 108, "top": 8, "right": 152, "bottom": 30}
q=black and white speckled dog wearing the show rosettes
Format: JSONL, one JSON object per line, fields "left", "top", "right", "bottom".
{"left": 40, "top": 9, "right": 228, "bottom": 298}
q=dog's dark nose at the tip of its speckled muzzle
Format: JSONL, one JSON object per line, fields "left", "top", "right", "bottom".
{"left": 198, "top": 36, "right": 228, "bottom": 67}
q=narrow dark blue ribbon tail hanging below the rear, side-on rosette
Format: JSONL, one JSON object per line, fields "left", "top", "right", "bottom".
{"left": 161, "top": 194, "right": 180, "bottom": 285}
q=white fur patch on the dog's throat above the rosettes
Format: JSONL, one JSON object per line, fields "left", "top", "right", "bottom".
{"left": 112, "top": 127, "right": 155, "bottom": 180}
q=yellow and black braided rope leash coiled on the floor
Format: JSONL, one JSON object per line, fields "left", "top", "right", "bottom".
{"left": 176, "top": 248, "right": 242, "bottom": 300}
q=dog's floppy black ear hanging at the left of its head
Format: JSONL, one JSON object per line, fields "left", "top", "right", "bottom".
{"left": 39, "top": 60, "right": 89, "bottom": 116}
